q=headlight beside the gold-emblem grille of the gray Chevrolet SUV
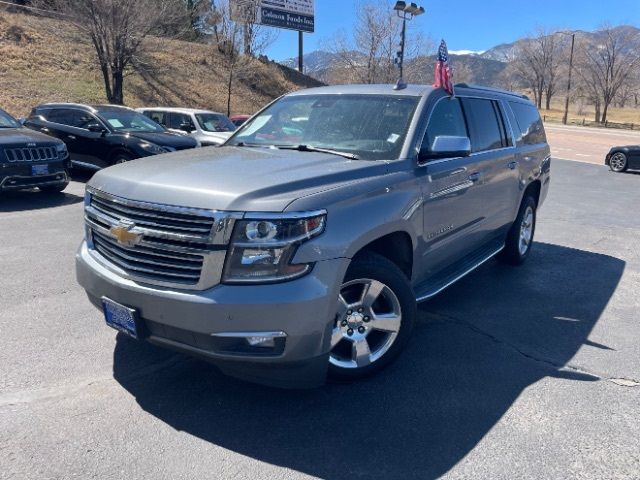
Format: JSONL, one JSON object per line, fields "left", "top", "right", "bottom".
{"left": 223, "top": 212, "right": 326, "bottom": 283}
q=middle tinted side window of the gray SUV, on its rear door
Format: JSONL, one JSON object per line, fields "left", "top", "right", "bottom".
{"left": 462, "top": 98, "right": 506, "bottom": 152}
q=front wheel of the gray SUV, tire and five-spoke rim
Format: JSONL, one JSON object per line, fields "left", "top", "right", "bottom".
{"left": 328, "top": 253, "right": 417, "bottom": 381}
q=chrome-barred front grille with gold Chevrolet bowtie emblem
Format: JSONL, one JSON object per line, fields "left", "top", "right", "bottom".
{"left": 85, "top": 189, "right": 237, "bottom": 289}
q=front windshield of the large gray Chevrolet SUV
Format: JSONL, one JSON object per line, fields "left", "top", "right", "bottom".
{"left": 228, "top": 95, "right": 419, "bottom": 160}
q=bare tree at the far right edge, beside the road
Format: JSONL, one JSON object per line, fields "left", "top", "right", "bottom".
{"left": 576, "top": 26, "right": 640, "bottom": 122}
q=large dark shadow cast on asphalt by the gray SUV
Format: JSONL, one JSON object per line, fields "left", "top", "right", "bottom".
{"left": 114, "top": 243, "right": 625, "bottom": 480}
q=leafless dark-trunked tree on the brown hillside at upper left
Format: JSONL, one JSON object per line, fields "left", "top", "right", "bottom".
{"left": 40, "top": 0, "right": 184, "bottom": 104}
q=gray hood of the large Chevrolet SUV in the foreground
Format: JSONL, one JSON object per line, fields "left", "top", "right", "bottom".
{"left": 90, "top": 142, "right": 388, "bottom": 212}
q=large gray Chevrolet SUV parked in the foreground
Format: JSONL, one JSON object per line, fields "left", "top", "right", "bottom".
{"left": 77, "top": 85, "right": 550, "bottom": 387}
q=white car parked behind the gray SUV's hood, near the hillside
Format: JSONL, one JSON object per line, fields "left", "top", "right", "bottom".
{"left": 137, "top": 107, "right": 236, "bottom": 147}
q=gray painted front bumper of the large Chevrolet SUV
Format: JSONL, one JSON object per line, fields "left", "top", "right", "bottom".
{"left": 76, "top": 242, "right": 348, "bottom": 388}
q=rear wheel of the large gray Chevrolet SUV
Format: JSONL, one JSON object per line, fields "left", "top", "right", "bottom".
{"left": 498, "top": 195, "right": 537, "bottom": 265}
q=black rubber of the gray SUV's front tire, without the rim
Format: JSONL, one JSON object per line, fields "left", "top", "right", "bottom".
{"left": 329, "top": 253, "right": 417, "bottom": 381}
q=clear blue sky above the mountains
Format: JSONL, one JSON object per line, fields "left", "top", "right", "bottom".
{"left": 266, "top": 0, "right": 640, "bottom": 60}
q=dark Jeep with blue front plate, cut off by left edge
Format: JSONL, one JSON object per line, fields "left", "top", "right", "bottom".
{"left": 0, "top": 109, "right": 71, "bottom": 193}
